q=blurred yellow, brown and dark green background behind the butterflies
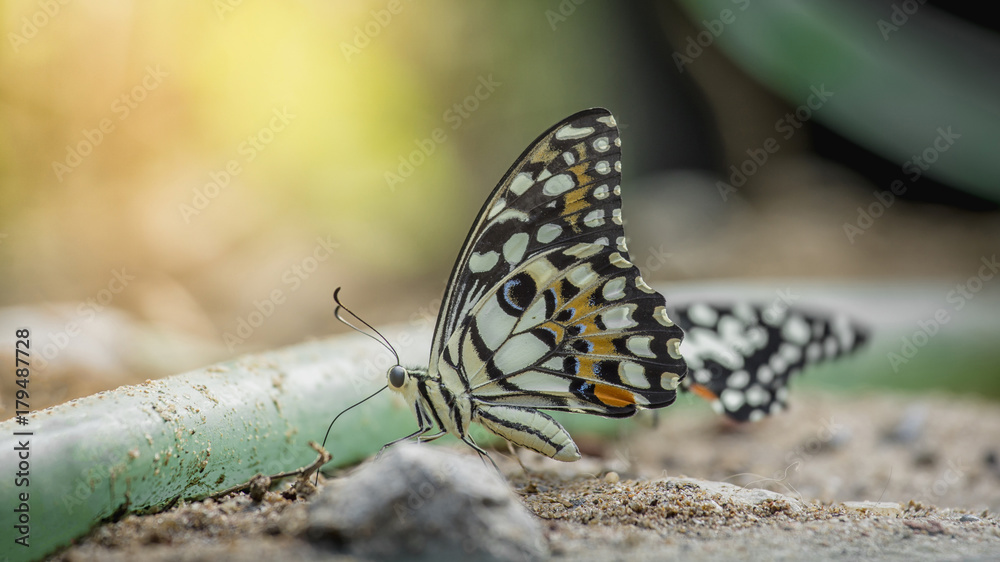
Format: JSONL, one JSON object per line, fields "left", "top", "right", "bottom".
{"left": 0, "top": 0, "right": 1000, "bottom": 412}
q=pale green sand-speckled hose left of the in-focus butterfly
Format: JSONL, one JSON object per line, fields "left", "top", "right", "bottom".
{"left": 0, "top": 327, "right": 615, "bottom": 560}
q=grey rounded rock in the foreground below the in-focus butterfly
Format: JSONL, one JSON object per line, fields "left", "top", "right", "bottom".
{"left": 306, "top": 444, "right": 547, "bottom": 560}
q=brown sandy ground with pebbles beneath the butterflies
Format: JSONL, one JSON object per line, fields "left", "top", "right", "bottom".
{"left": 55, "top": 390, "right": 1000, "bottom": 561}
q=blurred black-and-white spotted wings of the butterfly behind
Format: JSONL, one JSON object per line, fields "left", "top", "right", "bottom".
{"left": 672, "top": 303, "right": 867, "bottom": 421}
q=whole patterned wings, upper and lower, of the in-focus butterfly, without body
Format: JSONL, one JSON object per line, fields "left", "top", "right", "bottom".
{"left": 431, "top": 109, "right": 686, "bottom": 420}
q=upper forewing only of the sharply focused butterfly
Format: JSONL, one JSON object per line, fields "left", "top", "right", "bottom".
{"left": 430, "top": 109, "right": 640, "bottom": 369}
